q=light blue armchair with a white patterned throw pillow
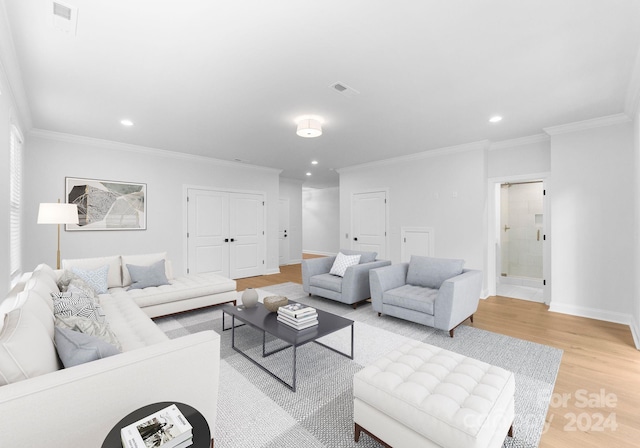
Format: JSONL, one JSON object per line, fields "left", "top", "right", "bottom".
{"left": 302, "top": 250, "right": 391, "bottom": 309}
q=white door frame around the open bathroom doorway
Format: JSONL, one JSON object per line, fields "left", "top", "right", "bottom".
{"left": 486, "top": 172, "right": 551, "bottom": 305}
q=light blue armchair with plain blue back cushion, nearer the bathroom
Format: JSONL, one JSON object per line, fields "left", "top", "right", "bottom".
{"left": 369, "top": 255, "right": 482, "bottom": 337}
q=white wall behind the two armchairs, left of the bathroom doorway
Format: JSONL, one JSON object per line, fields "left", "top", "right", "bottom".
{"left": 340, "top": 143, "right": 487, "bottom": 280}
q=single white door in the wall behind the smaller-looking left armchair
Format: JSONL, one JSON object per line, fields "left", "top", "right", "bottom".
{"left": 351, "top": 191, "right": 387, "bottom": 258}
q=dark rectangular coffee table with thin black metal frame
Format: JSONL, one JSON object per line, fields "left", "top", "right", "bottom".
{"left": 222, "top": 301, "right": 353, "bottom": 392}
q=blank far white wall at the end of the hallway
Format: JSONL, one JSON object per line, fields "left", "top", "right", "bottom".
{"left": 302, "top": 187, "right": 340, "bottom": 255}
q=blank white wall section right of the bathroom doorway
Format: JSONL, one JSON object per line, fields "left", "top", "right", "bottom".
{"left": 547, "top": 123, "right": 637, "bottom": 323}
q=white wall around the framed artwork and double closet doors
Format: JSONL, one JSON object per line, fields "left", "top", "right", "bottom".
{"left": 24, "top": 132, "right": 279, "bottom": 273}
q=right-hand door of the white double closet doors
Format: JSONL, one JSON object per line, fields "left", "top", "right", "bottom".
{"left": 229, "top": 193, "right": 264, "bottom": 278}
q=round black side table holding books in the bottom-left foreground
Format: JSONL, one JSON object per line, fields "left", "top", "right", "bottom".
{"left": 102, "top": 401, "right": 213, "bottom": 448}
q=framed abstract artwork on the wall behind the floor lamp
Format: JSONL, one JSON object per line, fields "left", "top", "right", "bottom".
{"left": 65, "top": 177, "right": 147, "bottom": 231}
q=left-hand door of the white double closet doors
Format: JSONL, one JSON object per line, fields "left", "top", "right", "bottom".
{"left": 187, "top": 189, "right": 229, "bottom": 277}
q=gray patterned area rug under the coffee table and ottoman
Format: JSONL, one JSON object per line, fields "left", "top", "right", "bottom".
{"left": 156, "top": 283, "right": 562, "bottom": 448}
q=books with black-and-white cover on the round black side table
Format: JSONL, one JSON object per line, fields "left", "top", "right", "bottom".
{"left": 120, "top": 404, "right": 193, "bottom": 448}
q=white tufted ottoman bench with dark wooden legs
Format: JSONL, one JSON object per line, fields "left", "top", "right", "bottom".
{"left": 353, "top": 341, "right": 515, "bottom": 448}
